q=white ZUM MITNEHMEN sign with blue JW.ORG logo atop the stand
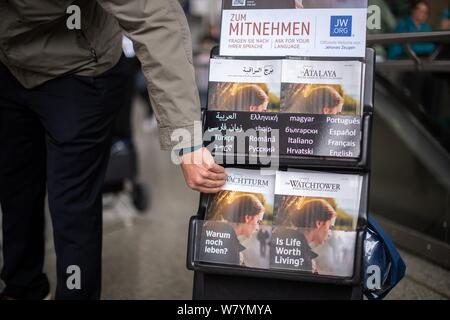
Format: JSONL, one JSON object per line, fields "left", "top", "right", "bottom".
{"left": 220, "top": 0, "right": 368, "bottom": 57}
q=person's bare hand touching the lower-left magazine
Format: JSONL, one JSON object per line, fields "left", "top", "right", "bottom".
{"left": 180, "top": 148, "right": 226, "bottom": 193}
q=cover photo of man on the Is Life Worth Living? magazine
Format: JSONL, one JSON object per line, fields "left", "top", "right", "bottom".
{"left": 270, "top": 195, "right": 357, "bottom": 277}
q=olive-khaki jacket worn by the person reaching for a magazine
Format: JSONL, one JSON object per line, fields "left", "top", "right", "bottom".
{"left": 0, "top": 0, "right": 200, "bottom": 149}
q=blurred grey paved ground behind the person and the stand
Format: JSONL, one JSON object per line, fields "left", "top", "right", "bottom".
{"left": 0, "top": 102, "right": 450, "bottom": 299}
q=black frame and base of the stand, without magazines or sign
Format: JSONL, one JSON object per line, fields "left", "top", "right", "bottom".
{"left": 187, "top": 49, "right": 375, "bottom": 300}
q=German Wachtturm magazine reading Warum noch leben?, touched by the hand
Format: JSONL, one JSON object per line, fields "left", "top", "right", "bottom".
{"left": 198, "top": 168, "right": 275, "bottom": 269}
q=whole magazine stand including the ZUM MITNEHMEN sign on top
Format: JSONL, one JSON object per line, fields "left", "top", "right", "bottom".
{"left": 187, "top": 0, "right": 375, "bottom": 299}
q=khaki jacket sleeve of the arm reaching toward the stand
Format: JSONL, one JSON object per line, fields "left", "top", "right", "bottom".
{"left": 97, "top": 0, "right": 201, "bottom": 150}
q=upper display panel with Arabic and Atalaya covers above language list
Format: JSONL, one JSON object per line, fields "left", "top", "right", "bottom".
{"left": 204, "top": 59, "right": 364, "bottom": 158}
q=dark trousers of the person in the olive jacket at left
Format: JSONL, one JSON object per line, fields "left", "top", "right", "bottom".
{"left": 0, "top": 60, "right": 124, "bottom": 299}
